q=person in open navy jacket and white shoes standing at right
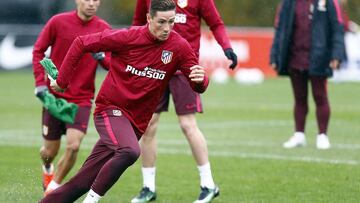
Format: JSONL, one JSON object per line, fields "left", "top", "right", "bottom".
{"left": 270, "top": 0, "right": 345, "bottom": 149}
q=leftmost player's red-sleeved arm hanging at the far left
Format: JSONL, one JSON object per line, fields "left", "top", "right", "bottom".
{"left": 32, "top": 18, "right": 56, "bottom": 96}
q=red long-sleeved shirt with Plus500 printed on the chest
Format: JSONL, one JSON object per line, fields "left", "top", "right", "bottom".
{"left": 57, "top": 26, "right": 209, "bottom": 135}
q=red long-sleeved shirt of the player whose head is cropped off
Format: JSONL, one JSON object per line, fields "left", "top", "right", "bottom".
{"left": 133, "top": 0, "right": 231, "bottom": 57}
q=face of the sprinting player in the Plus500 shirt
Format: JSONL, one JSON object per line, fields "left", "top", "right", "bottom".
{"left": 147, "top": 10, "right": 175, "bottom": 41}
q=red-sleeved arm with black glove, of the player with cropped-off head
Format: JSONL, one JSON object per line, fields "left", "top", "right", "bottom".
{"left": 200, "top": 0, "right": 237, "bottom": 69}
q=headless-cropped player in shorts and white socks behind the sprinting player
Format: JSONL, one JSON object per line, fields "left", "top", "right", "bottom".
{"left": 131, "top": 0, "right": 237, "bottom": 203}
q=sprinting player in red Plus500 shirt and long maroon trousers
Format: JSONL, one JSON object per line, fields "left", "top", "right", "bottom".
{"left": 41, "top": 0, "right": 209, "bottom": 202}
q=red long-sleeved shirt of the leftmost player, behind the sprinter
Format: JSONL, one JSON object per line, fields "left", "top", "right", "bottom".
{"left": 32, "top": 11, "right": 110, "bottom": 106}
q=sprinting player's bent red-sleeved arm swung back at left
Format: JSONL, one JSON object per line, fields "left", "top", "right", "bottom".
{"left": 56, "top": 30, "right": 127, "bottom": 90}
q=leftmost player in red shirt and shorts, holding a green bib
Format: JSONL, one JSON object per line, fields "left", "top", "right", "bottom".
{"left": 33, "top": 0, "right": 110, "bottom": 194}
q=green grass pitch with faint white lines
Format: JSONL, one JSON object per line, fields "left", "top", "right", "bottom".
{"left": 0, "top": 71, "right": 360, "bottom": 203}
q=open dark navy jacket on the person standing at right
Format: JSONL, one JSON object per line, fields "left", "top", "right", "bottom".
{"left": 270, "top": 0, "right": 345, "bottom": 76}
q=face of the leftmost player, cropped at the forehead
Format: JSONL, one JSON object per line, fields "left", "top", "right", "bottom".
{"left": 76, "top": 0, "right": 100, "bottom": 20}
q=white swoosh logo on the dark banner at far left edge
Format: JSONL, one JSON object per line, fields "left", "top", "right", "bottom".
{"left": 0, "top": 34, "right": 33, "bottom": 70}
